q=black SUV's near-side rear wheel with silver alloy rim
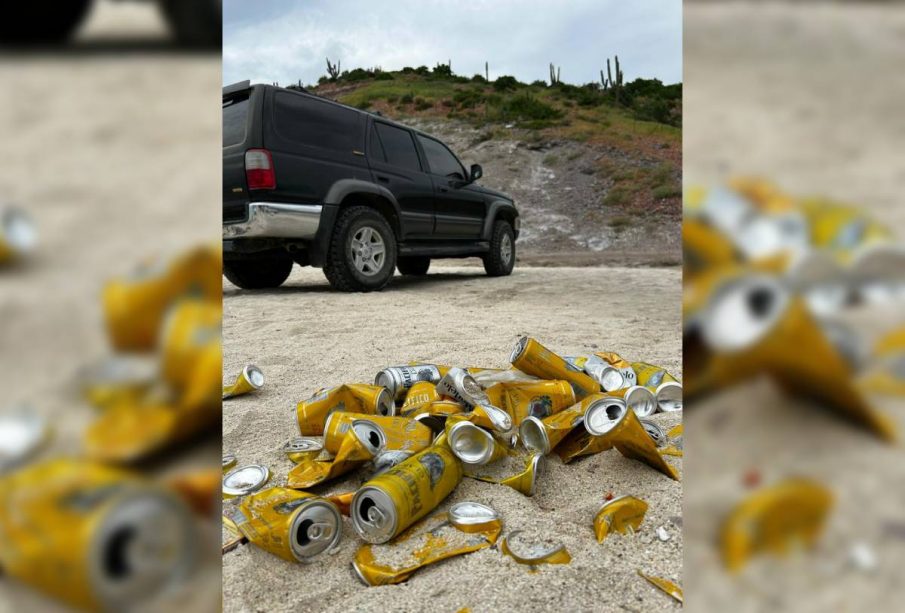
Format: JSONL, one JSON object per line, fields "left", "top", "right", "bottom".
{"left": 324, "top": 206, "right": 396, "bottom": 292}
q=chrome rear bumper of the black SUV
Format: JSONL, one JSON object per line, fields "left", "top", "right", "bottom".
{"left": 223, "top": 202, "right": 323, "bottom": 240}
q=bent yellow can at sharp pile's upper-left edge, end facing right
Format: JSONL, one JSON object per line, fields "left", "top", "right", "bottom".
{"left": 296, "top": 383, "right": 396, "bottom": 436}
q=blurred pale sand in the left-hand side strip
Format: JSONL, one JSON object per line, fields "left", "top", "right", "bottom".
{"left": 0, "top": 2, "right": 221, "bottom": 611}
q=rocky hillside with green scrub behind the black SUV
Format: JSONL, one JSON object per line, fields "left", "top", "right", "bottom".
{"left": 309, "top": 69, "right": 682, "bottom": 266}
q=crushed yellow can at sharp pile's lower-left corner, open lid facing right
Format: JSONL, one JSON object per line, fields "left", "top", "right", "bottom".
{"left": 229, "top": 487, "right": 342, "bottom": 562}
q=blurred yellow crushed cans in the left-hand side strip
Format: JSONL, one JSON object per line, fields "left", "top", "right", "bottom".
{"left": 0, "top": 245, "right": 222, "bottom": 611}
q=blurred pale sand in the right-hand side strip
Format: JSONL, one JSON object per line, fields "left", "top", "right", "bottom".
{"left": 684, "top": 2, "right": 905, "bottom": 611}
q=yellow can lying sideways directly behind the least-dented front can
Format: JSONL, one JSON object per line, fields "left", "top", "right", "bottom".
{"left": 324, "top": 412, "right": 434, "bottom": 455}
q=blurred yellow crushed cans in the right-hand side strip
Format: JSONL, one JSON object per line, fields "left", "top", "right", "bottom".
{"left": 683, "top": 178, "right": 905, "bottom": 571}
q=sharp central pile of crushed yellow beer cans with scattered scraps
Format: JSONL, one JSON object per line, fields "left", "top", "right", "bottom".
{"left": 223, "top": 337, "right": 682, "bottom": 597}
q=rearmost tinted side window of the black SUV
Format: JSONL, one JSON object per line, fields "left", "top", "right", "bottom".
{"left": 273, "top": 92, "right": 364, "bottom": 153}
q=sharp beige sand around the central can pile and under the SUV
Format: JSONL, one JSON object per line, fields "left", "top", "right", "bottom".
{"left": 223, "top": 266, "right": 682, "bottom": 612}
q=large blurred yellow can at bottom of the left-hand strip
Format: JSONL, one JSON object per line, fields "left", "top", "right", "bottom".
{"left": 0, "top": 459, "right": 199, "bottom": 611}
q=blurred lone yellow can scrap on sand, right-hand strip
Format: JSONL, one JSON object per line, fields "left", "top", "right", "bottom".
{"left": 720, "top": 478, "right": 833, "bottom": 572}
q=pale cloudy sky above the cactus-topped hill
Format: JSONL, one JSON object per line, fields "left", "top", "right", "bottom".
{"left": 223, "top": 0, "right": 682, "bottom": 85}
